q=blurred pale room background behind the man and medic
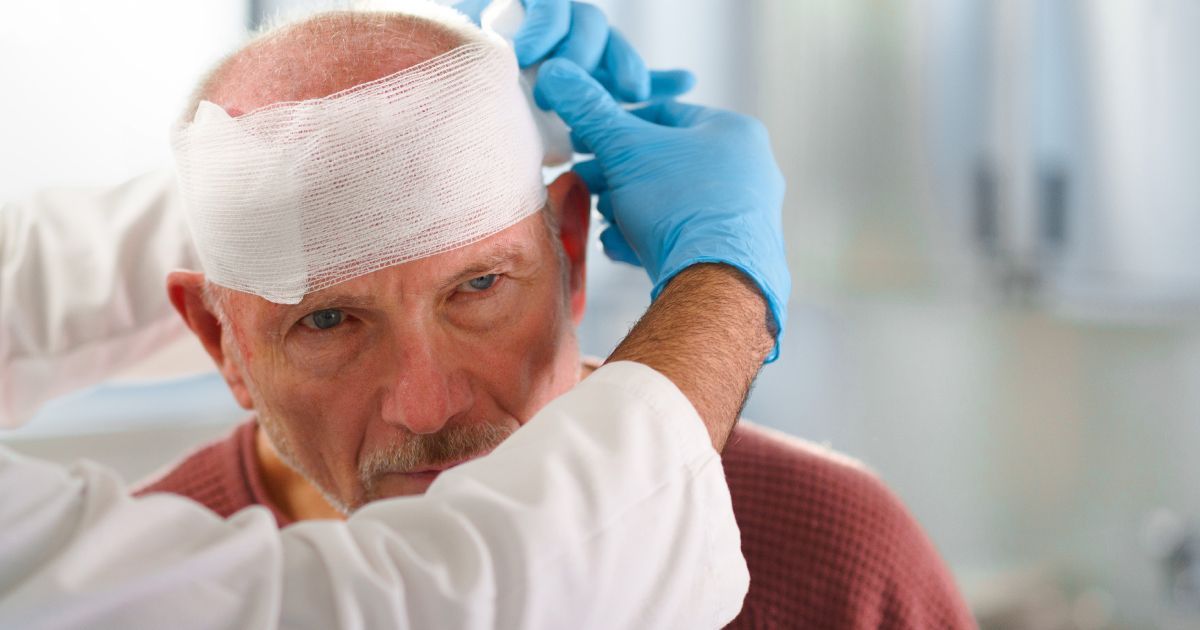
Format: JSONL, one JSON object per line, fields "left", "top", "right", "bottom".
{"left": 0, "top": 0, "right": 1200, "bottom": 630}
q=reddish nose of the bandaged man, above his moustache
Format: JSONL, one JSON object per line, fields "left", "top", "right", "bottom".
{"left": 383, "top": 338, "right": 473, "bottom": 433}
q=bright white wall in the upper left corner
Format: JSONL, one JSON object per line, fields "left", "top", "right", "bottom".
{"left": 0, "top": 0, "right": 246, "bottom": 199}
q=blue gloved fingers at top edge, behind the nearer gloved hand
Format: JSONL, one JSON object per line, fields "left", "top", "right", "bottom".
{"left": 455, "top": 0, "right": 696, "bottom": 103}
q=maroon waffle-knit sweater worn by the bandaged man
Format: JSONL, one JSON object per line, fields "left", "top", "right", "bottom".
{"left": 138, "top": 420, "right": 976, "bottom": 630}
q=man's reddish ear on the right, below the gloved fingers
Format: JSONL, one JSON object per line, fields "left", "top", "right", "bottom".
{"left": 547, "top": 170, "right": 592, "bottom": 325}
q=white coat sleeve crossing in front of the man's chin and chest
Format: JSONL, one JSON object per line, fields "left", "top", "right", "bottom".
{"left": 0, "top": 362, "right": 749, "bottom": 629}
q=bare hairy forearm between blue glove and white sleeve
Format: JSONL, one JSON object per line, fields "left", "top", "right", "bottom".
{"left": 608, "top": 264, "right": 774, "bottom": 450}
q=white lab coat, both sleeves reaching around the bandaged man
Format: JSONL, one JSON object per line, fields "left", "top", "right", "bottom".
{"left": 0, "top": 175, "right": 749, "bottom": 629}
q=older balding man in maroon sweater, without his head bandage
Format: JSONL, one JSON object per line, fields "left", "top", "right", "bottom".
{"left": 133, "top": 6, "right": 972, "bottom": 628}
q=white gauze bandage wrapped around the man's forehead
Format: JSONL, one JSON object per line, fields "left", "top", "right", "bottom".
{"left": 173, "top": 36, "right": 546, "bottom": 304}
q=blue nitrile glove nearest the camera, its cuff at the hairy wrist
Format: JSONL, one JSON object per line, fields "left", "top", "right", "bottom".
{"left": 534, "top": 59, "right": 792, "bottom": 362}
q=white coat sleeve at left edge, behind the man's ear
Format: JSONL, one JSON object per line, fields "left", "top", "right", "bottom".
{"left": 0, "top": 169, "right": 197, "bottom": 427}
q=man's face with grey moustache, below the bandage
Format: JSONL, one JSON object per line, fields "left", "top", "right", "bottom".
{"left": 188, "top": 199, "right": 587, "bottom": 510}
